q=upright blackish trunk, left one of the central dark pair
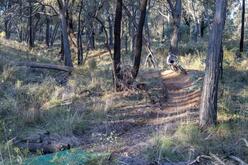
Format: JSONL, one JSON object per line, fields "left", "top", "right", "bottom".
{"left": 113, "top": 0, "right": 122, "bottom": 84}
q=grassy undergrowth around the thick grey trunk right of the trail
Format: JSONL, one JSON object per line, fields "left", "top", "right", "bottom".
{"left": 145, "top": 50, "right": 248, "bottom": 164}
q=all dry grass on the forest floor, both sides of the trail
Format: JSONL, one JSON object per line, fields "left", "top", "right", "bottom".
{"left": 0, "top": 40, "right": 248, "bottom": 164}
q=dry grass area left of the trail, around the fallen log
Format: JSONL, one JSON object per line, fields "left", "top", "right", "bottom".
{"left": 0, "top": 39, "right": 115, "bottom": 164}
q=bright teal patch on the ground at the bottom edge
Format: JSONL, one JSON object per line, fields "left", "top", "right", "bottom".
{"left": 23, "top": 149, "right": 109, "bottom": 165}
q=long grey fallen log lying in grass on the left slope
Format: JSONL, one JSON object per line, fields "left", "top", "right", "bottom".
{"left": 14, "top": 62, "right": 73, "bottom": 72}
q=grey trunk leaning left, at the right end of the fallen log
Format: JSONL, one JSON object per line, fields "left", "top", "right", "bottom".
{"left": 57, "top": 0, "right": 73, "bottom": 67}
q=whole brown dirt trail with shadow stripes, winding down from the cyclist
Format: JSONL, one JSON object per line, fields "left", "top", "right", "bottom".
{"left": 80, "top": 71, "right": 200, "bottom": 161}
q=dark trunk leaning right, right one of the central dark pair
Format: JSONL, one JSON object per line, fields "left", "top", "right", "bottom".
{"left": 132, "top": 0, "right": 148, "bottom": 79}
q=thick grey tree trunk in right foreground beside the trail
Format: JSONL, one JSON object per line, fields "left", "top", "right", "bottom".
{"left": 200, "top": 0, "right": 227, "bottom": 128}
